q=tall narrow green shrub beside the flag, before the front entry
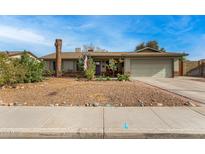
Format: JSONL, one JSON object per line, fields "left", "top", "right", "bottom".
{"left": 85, "top": 58, "right": 96, "bottom": 80}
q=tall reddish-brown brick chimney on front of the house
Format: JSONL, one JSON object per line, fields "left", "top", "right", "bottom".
{"left": 55, "top": 39, "right": 62, "bottom": 77}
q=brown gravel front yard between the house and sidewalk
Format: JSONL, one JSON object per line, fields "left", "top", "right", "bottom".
{"left": 0, "top": 78, "right": 194, "bottom": 106}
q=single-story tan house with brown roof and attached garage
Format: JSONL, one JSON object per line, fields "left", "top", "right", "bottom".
{"left": 41, "top": 47, "right": 187, "bottom": 77}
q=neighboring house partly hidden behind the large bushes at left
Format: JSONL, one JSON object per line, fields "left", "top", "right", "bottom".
{"left": 0, "top": 51, "right": 39, "bottom": 60}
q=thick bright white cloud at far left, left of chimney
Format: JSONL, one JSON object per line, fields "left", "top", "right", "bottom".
{"left": 0, "top": 25, "right": 51, "bottom": 46}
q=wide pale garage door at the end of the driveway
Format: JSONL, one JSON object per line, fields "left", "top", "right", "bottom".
{"left": 130, "top": 59, "right": 172, "bottom": 77}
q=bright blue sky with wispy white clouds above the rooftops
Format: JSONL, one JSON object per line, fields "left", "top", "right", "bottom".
{"left": 0, "top": 16, "right": 205, "bottom": 60}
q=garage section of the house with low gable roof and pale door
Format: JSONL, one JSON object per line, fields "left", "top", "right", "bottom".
{"left": 124, "top": 47, "right": 188, "bottom": 78}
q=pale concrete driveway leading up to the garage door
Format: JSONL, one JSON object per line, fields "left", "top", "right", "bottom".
{"left": 134, "top": 77, "right": 205, "bottom": 105}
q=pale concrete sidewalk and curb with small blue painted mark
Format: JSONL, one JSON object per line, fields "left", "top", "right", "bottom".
{"left": 0, "top": 106, "right": 205, "bottom": 138}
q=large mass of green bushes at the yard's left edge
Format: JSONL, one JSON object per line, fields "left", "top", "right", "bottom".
{"left": 0, "top": 53, "right": 44, "bottom": 85}
